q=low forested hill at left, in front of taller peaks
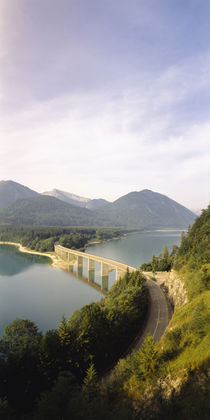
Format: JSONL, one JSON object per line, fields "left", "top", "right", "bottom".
{"left": 0, "top": 194, "right": 95, "bottom": 226}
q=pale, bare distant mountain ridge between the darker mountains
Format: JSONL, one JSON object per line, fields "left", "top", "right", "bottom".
{"left": 43, "top": 188, "right": 109, "bottom": 210}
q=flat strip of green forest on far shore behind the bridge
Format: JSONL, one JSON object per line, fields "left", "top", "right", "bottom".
{"left": 0, "top": 227, "right": 130, "bottom": 252}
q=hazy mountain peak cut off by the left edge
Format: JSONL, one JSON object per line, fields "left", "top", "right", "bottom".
{"left": 0, "top": 181, "right": 39, "bottom": 208}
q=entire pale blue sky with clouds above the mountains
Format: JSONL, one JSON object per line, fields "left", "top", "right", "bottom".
{"left": 0, "top": 0, "right": 210, "bottom": 210}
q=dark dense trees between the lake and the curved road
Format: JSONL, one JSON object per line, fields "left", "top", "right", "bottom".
{"left": 0, "top": 271, "right": 148, "bottom": 419}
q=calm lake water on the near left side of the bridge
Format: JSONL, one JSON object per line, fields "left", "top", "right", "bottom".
{"left": 0, "top": 245, "right": 103, "bottom": 335}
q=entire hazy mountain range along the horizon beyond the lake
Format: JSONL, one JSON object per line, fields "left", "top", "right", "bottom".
{"left": 0, "top": 181, "right": 196, "bottom": 229}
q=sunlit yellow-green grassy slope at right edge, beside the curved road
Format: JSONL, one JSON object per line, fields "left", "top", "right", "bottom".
{"left": 160, "top": 291, "right": 210, "bottom": 372}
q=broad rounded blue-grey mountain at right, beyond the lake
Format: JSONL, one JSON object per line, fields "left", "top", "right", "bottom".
{"left": 98, "top": 190, "right": 196, "bottom": 229}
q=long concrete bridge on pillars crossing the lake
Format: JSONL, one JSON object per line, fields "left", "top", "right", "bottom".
{"left": 54, "top": 244, "right": 137, "bottom": 290}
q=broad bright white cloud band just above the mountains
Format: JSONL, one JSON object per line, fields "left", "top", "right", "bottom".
{"left": 0, "top": 53, "right": 210, "bottom": 207}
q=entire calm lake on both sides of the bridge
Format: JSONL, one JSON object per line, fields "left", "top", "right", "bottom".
{"left": 0, "top": 231, "right": 181, "bottom": 335}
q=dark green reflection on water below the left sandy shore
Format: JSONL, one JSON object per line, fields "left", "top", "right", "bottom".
{"left": 0, "top": 245, "right": 50, "bottom": 277}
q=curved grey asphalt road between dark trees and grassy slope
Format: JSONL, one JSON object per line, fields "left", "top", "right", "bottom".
{"left": 133, "top": 278, "right": 169, "bottom": 350}
